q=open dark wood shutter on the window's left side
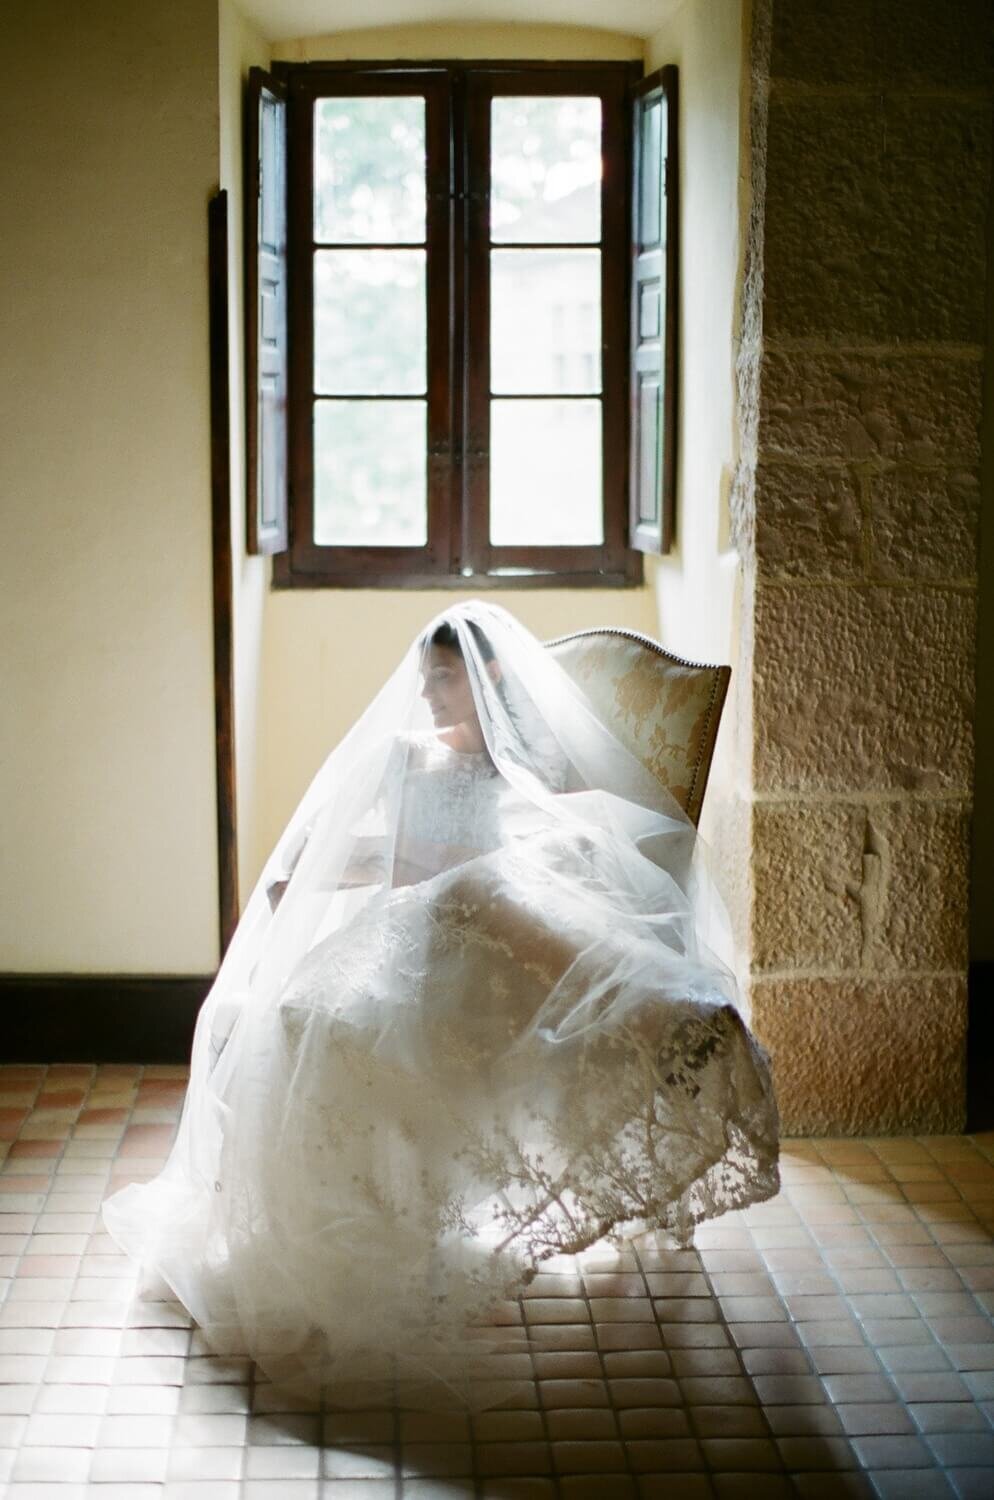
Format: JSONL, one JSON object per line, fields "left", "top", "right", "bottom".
{"left": 244, "top": 68, "right": 289, "bottom": 552}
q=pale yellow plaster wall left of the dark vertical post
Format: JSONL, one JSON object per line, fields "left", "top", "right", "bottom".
{"left": 0, "top": 0, "right": 217, "bottom": 974}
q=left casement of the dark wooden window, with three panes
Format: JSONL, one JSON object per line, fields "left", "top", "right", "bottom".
{"left": 274, "top": 68, "right": 449, "bottom": 585}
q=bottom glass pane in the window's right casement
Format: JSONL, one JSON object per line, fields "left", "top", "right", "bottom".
{"left": 490, "top": 401, "right": 604, "bottom": 548}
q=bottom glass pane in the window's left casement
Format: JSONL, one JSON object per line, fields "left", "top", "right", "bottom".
{"left": 313, "top": 401, "right": 427, "bottom": 548}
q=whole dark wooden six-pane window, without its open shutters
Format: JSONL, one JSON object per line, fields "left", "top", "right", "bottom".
{"left": 253, "top": 63, "right": 680, "bottom": 587}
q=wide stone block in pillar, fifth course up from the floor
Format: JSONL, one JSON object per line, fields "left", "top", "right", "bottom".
{"left": 759, "top": 348, "right": 982, "bottom": 468}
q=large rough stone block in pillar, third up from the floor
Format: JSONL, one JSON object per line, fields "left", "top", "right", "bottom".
{"left": 753, "top": 584, "right": 975, "bottom": 797}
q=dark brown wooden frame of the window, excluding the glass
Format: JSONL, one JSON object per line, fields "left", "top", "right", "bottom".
{"left": 273, "top": 60, "right": 643, "bottom": 590}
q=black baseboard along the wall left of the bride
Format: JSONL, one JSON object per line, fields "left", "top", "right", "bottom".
{"left": 0, "top": 974, "right": 213, "bottom": 1062}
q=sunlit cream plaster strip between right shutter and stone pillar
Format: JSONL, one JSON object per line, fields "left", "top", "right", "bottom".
{"left": 646, "top": 0, "right": 750, "bottom": 966}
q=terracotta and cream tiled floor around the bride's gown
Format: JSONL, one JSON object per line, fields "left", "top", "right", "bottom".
{"left": 0, "top": 1067, "right": 994, "bottom": 1500}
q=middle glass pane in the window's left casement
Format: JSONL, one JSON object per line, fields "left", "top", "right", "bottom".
{"left": 313, "top": 251, "right": 427, "bottom": 396}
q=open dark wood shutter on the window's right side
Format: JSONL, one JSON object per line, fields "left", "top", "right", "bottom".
{"left": 630, "top": 68, "right": 679, "bottom": 552}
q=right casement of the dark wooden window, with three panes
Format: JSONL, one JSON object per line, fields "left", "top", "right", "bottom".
{"left": 460, "top": 68, "right": 639, "bottom": 582}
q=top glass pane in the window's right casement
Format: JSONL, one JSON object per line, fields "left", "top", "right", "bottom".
{"left": 490, "top": 95, "right": 601, "bottom": 245}
